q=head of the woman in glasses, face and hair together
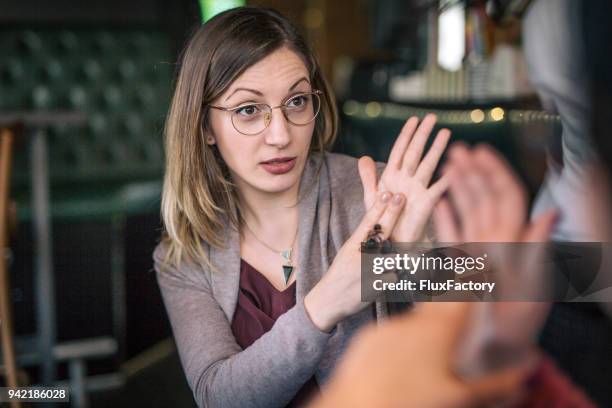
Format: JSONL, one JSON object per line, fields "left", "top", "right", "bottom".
{"left": 162, "top": 7, "right": 337, "bottom": 264}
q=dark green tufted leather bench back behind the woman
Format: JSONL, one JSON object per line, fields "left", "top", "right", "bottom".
{"left": 0, "top": 28, "right": 173, "bottom": 221}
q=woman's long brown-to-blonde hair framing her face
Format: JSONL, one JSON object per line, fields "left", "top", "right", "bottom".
{"left": 161, "top": 7, "right": 338, "bottom": 269}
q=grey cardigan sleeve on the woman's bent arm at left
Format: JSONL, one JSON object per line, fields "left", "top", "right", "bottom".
{"left": 153, "top": 247, "right": 332, "bottom": 407}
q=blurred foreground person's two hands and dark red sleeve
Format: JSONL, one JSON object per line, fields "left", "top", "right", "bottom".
{"left": 313, "top": 144, "right": 596, "bottom": 408}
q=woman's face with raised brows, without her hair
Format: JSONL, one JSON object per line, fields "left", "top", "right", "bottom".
{"left": 207, "top": 48, "right": 315, "bottom": 198}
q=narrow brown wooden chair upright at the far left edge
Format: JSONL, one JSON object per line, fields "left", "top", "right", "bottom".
{"left": 0, "top": 127, "right": 20, "bottom": 407}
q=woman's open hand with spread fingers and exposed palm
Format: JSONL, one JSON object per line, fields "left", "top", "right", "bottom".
{"left": 359, "top": 114, "right": 451, "bottom": 242}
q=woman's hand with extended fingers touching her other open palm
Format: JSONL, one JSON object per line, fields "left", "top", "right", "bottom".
{"left": 304, "top": 192, "right": 406, "bottom": 331}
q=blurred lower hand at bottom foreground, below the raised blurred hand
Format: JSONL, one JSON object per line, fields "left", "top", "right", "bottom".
{"left": 311, "top": 303, "right": 532, "bottom": 408}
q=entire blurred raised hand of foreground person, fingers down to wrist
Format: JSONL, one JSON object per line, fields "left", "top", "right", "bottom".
{"left": 434, "top": 143, "right": 556, "bottom": 377}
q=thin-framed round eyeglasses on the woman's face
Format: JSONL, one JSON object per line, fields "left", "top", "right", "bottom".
{"left": 208, "top": 90, "right": 323, "bottom": 136}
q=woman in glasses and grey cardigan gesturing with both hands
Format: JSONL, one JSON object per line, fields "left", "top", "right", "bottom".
{"left": 154, "top": 8, "right": 450, "bottom": 407}
